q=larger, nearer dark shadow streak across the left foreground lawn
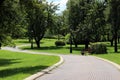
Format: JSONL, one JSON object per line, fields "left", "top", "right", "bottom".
{"left": 0, "top": 65, "right": 48, "bottom": 78}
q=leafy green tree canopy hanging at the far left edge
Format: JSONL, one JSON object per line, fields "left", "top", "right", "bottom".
{"left": 0, "top": 0, "right": 24, "bottom": 42}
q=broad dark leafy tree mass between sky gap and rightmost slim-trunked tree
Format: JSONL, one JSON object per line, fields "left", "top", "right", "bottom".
{"left": 68, "top": 0, "right": 105, "bottom": 48}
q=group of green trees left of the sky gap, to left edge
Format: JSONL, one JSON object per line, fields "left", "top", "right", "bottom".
{"left": 0, "top": 0, "right": 57, "bottom": 48}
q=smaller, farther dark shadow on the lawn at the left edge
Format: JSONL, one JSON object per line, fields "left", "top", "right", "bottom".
{"left": 0, "top": 59, "right": 20, "bottom": 66}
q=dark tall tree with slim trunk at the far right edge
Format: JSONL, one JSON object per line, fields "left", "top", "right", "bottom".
{"left": 110, "top": 0, "right": 120, "bottom": 52}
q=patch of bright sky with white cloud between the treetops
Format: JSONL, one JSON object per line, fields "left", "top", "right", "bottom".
{"left": 46, "top": 0, "right": 68, "bottom": 13}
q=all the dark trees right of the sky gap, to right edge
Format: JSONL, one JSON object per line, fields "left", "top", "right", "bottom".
{"left": 64, "top": 0, "right": 120, "bottom": 52}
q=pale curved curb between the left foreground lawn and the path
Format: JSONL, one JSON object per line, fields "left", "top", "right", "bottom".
{"left": 24, "top": 56, "right": 64, "bottom": 80}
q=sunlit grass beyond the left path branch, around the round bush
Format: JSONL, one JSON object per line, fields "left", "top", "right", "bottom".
{"left": 17, "top": 39, "right": 84, "bottom": 54}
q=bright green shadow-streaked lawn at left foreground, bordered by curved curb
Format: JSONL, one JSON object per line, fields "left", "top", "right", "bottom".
{"left": 0, "top": 50, "right": 60, "bottom": 80}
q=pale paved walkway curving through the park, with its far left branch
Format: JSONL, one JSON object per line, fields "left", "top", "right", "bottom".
{"left": 4, "top": 48, "right": 120, "bottom": 80}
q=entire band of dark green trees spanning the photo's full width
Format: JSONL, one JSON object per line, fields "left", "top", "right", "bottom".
{"left": 0, "top": 0, "right": 120, "bottom": 52}
